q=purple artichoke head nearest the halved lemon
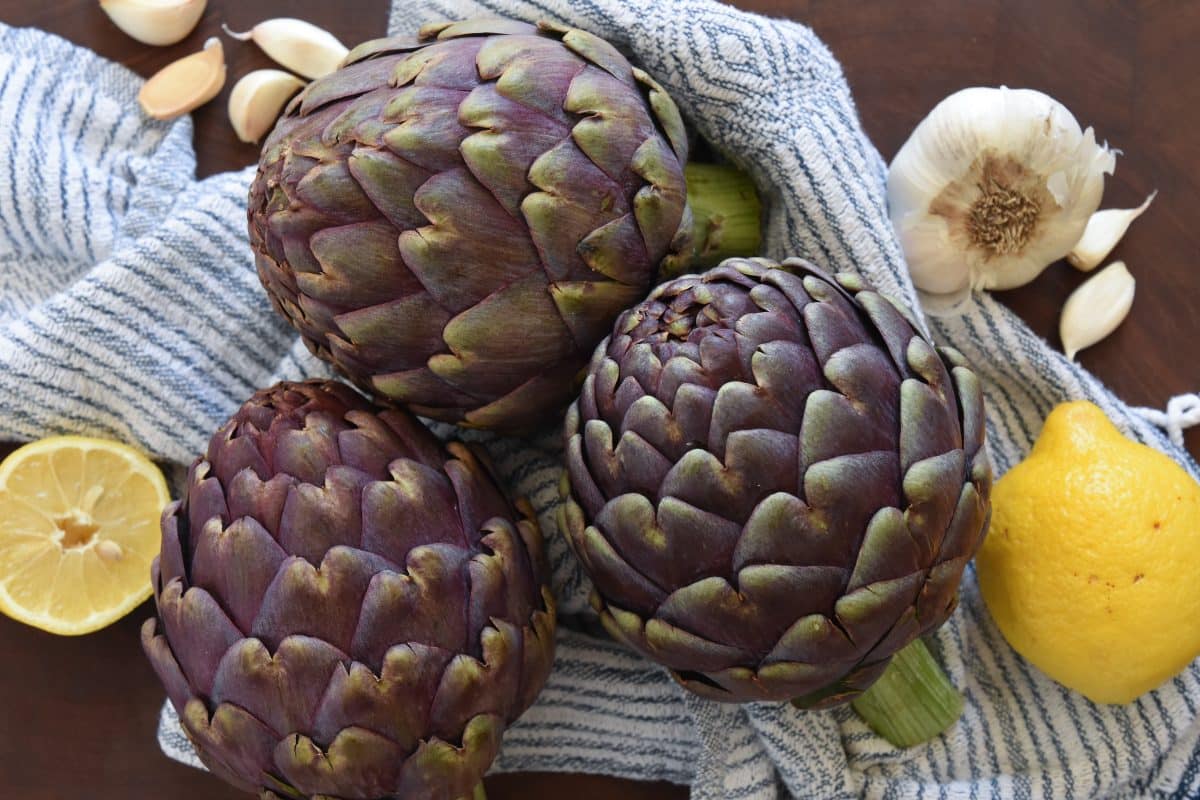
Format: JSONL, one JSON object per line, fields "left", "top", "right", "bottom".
{"left": 142, "top": 383, "right": 554, "bottom": 800}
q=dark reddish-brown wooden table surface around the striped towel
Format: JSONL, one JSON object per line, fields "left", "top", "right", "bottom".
{"left": 0, "top": 0, "right": 1200, "bottom": 800}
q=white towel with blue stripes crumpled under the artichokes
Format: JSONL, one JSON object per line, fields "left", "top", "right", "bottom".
{"left": 0, "top": 0, "right": 1200, "bottom": 800}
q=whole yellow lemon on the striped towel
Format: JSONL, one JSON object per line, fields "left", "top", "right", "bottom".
{"left": 976, "top": 402, "right": 1200, "bottom": 703}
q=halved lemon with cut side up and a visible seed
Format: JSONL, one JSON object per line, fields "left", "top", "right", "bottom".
{"left": 0, "top": 437, "right": 170, "bottom": 636}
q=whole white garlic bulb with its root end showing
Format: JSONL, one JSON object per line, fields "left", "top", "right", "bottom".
{"left": 888, "top": 86, "right": 1116, "bottom": 313}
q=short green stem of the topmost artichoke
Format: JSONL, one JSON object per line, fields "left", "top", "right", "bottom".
{"left": 681, "top": 164, "right": 762, "bottom": 277}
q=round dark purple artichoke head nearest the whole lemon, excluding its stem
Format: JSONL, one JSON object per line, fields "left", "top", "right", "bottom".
{"left": 559, "top": 259, "right": 991, "bottom": 716}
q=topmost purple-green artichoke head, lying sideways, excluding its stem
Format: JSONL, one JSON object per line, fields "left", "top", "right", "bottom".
{"left": 248, "top": 19, "right": 691, "bottom": 431}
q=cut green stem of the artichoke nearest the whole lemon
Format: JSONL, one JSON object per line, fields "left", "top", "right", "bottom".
{"left": 851, "top": 639, "right": 962, "bottom": 747}
